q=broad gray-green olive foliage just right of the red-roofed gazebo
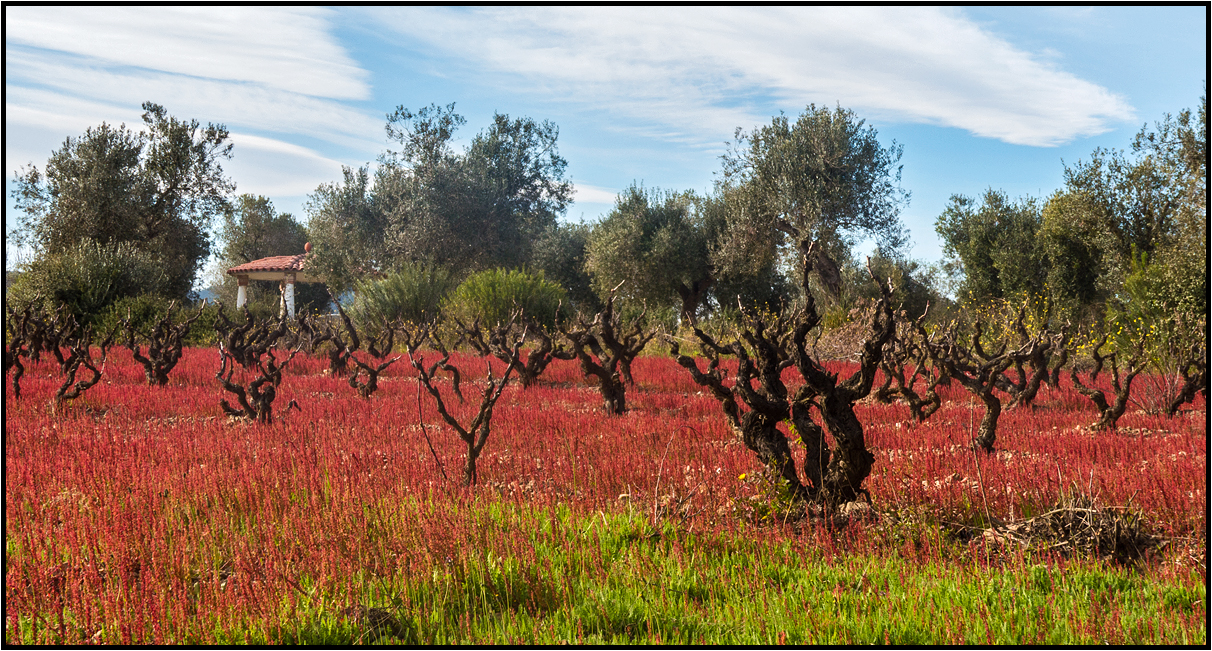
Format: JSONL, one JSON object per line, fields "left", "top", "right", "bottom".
{"left": 300, "top": 104, "right": 572, "bottom": 291}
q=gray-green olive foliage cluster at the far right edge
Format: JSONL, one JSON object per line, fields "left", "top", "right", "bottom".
{"left": 937, "top": 97, "right": 1208, "bottom": 318}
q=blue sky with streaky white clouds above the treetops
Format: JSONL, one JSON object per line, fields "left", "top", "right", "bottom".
{"left": 4, "top": 5, "right": 1208, "bottom": 281}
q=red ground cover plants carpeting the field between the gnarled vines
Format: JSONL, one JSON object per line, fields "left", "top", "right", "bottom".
{"left": 5, "top": 341, "right": 1207, "bottom": 644}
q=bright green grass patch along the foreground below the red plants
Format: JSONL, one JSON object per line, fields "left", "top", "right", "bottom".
{"left": 176, "top": 502, "right": 1207, "bottom": 645}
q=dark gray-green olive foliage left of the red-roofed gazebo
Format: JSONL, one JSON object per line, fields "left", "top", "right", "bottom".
{"left": 12, "top": 102, "right": 235, "bottom": 297}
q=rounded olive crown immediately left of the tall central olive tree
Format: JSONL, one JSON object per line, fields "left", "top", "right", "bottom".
{"left": 585, "top": 184, "right": 711, "bottom": 316}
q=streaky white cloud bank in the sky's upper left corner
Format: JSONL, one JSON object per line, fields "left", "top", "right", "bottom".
{"left": 5, "top": 6, "right": 383, "bottom": 194}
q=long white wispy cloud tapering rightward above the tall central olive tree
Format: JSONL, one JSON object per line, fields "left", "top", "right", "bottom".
{"left": 376, "top": 7, "right": 1133, "bottom": 147}
